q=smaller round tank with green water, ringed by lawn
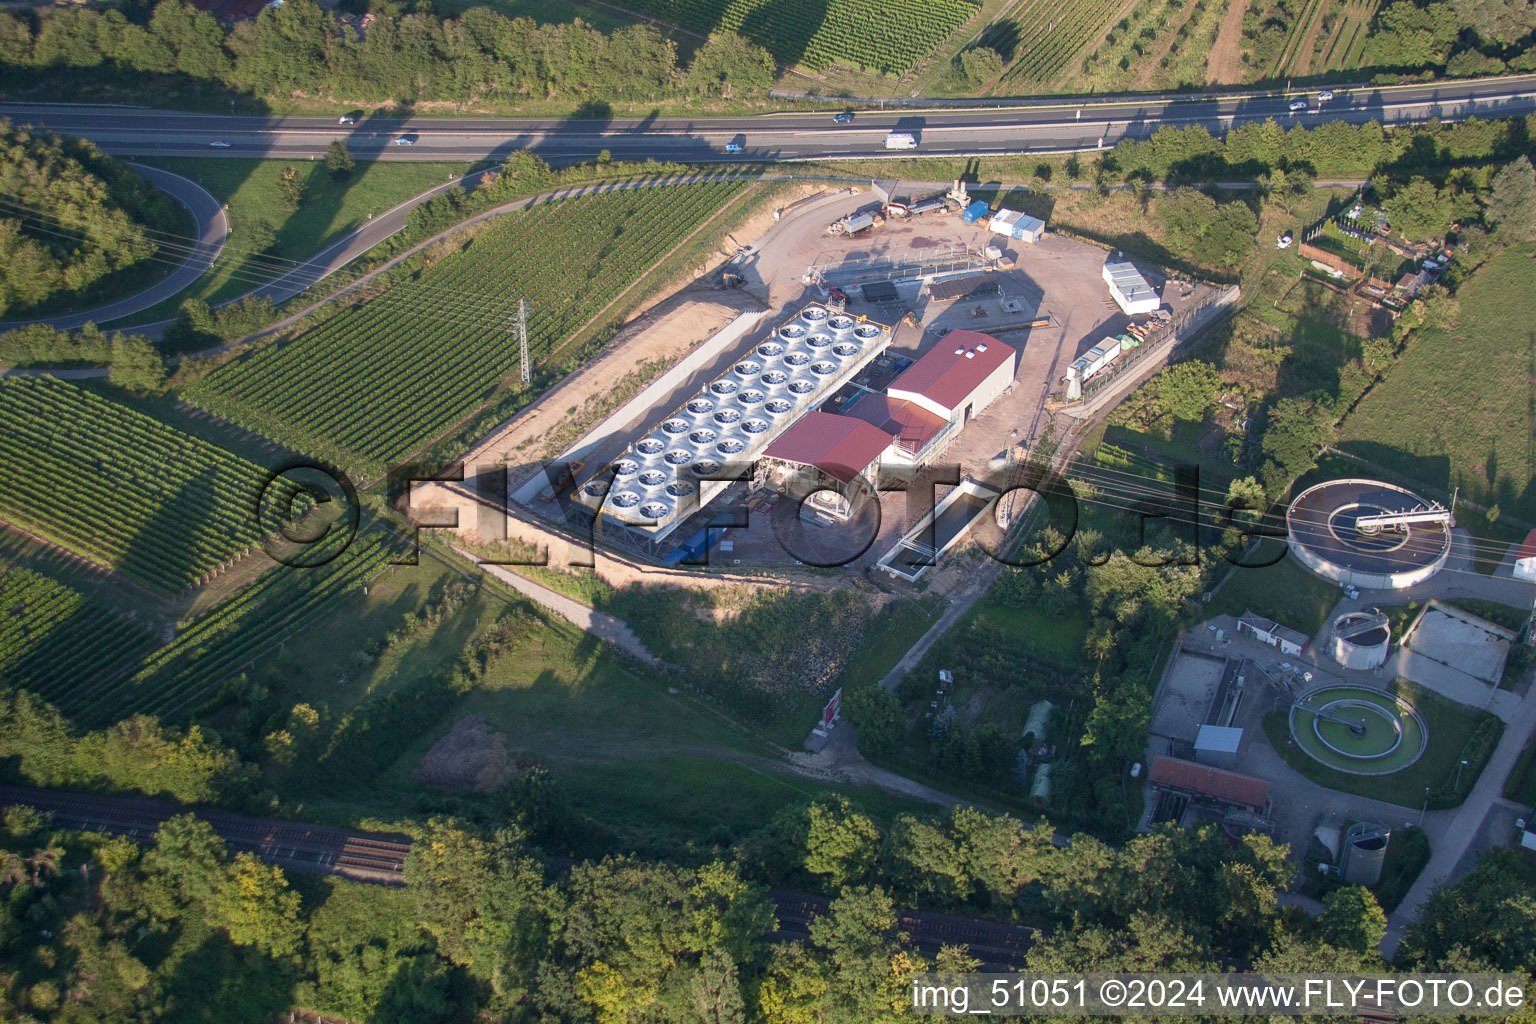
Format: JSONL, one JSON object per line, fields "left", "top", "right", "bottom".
{"left": 1290, "top": 686, "right": 1428, "bottom": 775}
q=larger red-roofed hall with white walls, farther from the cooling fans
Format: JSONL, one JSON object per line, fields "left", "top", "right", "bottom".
{"left": 848, "top": 330, "right": 1018, "bottom": 476}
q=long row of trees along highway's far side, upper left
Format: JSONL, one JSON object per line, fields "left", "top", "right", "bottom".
{"left": 0, "top": 0, "right": 774, "bottom": 109}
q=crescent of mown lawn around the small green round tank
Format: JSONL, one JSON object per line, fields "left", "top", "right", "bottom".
{"left": 1264, "top": 679, "right": 1504, "bottom": 811}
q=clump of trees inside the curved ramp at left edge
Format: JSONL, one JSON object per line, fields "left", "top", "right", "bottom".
{"left": 0, "top": 118, "right": 180, "bottom": 316}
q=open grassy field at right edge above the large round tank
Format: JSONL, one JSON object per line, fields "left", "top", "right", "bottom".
{"left": 1339, "top": 244, "right": 1536, "bottom": 520}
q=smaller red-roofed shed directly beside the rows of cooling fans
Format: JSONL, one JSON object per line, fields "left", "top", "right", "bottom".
{"left": 756, "top": 411, "right": 891, "bottom": 520}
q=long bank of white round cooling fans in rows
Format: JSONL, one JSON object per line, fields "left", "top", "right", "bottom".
{"left": 576, "top": 304, "right": 891, "bottom": 540}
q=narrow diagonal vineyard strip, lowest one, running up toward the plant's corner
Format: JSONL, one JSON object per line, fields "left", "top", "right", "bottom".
{"left": 74, "top": 528, "right": 399, "bottom": 725}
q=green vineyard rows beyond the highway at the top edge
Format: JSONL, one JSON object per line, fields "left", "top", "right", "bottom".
{"left": 611, "top": 0, "right": 978, "bottom": 75}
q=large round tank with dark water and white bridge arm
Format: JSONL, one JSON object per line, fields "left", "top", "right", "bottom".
{"left": 1286, "top": 479, "right": 1450, "bottom": 590}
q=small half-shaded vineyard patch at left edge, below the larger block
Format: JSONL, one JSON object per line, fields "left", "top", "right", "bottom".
{"left": 0, "top": 562, "right": 155, "bottom": 700}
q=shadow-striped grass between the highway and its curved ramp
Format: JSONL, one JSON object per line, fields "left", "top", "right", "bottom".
{"left": 122, "top": 157, "right": 468, "bottom": 321}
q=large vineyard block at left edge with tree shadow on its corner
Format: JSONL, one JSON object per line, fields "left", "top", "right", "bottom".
{"left": 0, "top": 378, "right": 264, "bottom": 593}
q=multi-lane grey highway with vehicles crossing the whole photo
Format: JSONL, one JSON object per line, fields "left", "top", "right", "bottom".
{"left": 0, "top": 75, "right": 1536, "bottom": 164}
